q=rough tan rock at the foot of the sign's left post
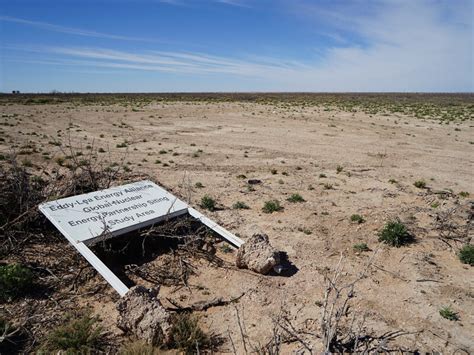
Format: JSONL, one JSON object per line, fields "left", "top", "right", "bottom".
{"left": 117, "top": 286, "right": 171, "bottom": 345}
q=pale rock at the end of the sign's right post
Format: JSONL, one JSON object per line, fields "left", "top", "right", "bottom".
{"left": 236, "top": 233, "right": 280, "bottom": 275}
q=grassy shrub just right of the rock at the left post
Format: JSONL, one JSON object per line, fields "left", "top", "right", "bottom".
{"left": 171, "top": 313, "right": 211, "bottom": 354}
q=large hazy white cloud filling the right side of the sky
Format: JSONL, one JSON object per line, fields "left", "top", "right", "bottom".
{"left": 287, "top": 0, "right": 474, "bottom": 91}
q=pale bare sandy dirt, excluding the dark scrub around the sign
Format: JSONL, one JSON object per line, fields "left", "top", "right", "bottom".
{"left": 0, "top": 102, "right": 474, "bottom": 353}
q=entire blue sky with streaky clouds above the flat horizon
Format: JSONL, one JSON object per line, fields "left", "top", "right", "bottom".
{"left": 0, "top": 0, "right": 474, "bottom": 92}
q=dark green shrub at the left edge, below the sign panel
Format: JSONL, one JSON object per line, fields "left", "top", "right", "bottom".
{"left": 0, "top": 264, "right": 33, "bottom": 301}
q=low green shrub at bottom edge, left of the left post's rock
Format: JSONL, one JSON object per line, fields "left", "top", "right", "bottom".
{"left": 42, "top": 315, "right": 103, "bottom": 354}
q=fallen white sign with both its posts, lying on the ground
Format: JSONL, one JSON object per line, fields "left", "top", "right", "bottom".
{"left": 39, "top": 180, "right": 243, "bottom": 296}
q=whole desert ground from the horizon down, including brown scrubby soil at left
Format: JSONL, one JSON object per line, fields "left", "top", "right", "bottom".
{"left": 0, "top": 95, "right": 474, "bottom": 354}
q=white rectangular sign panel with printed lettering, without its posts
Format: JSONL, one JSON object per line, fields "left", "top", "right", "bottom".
{"left": 39, "top": 180, "right": 188, "bottom": 244}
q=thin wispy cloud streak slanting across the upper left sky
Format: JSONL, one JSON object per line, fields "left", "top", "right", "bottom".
{"left": 0, "top": 15, "right": 156, "bottom": 42}
